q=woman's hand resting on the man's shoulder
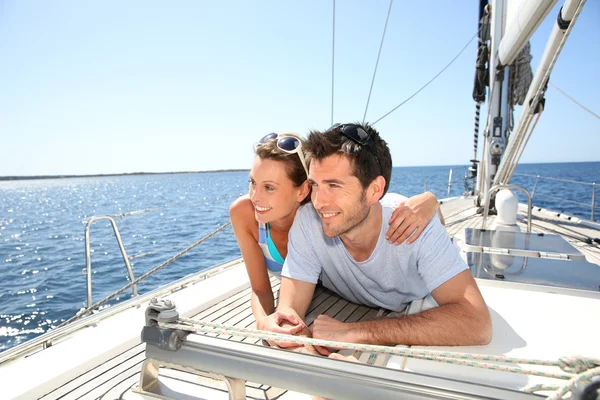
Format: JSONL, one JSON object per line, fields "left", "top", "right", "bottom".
{"left": 385, "top": 193, "right": 439, "bottom": 245}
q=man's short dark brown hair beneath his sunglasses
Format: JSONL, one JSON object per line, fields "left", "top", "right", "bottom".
{"left": 305, "top": 123, "right": 392, "bottom": 197}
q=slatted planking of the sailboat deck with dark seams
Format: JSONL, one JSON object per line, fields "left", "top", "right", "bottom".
{"left": 42, "top": 199, "right": 600, "bottom": 399}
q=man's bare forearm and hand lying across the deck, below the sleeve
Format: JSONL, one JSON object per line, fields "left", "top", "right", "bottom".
{"left": 313, "top": 270, "right": 492, "bottom": 346}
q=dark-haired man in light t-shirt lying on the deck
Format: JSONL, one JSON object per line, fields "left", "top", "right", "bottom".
{"left": 267, "top": 124, "right": 492, "bottom": 345}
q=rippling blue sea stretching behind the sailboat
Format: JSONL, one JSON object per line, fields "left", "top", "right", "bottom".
{"left": 0, "top": 162, "right": 600, "bottom": 350}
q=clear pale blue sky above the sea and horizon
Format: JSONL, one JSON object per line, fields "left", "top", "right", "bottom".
{"left": 0, "top": 0, "right": 600, "bottom": 176}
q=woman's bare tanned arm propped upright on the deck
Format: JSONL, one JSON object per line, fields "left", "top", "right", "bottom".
{"left": 229, "top": 195, "right": 275, "bottom": 329}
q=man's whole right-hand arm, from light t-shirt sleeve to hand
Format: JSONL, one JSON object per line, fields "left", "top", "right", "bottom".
{"left": 313, "top": 212, "right": 492, "bottom": 346}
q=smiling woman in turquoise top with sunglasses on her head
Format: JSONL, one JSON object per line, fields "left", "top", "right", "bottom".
{"left": 229, "top": 133, "right": 439, "bottom": 329}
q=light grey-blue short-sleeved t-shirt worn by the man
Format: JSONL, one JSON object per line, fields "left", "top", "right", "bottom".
{"left": 282, "top": 203, "right": 467, "bottom": 311}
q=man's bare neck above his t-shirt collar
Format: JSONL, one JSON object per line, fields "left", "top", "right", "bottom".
{"left": 340, "top": 202, "right": 383, "bottom": 262}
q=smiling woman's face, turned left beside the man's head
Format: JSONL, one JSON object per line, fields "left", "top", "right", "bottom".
{"left": 248, "top": 156, "right": 302, "bottom": 223}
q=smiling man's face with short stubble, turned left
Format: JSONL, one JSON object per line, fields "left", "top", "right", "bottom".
{"left": 308, "top": 154, "right": 371, "bottom": 238}
